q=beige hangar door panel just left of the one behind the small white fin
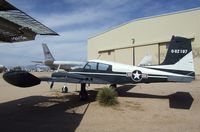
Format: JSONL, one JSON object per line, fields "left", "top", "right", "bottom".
{"left": 115, "top": 48, "right": 133, "bottom": 65}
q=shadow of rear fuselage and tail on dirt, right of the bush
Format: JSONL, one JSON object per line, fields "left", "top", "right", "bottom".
{"left": 116, "top": 85, "right": 194, "bottom": 109}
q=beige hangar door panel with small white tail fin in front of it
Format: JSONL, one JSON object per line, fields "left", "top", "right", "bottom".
{"left": 135, "top": 44, "right": 159, "bottom": 65}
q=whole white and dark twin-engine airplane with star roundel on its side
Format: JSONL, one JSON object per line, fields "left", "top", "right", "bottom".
{"left": 3, "top": 36, "right": 195, "bottom": 100}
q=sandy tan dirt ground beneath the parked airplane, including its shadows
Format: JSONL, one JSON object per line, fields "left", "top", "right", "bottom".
{"left": 0, "top": 73, "right": 200, "bottom": 132}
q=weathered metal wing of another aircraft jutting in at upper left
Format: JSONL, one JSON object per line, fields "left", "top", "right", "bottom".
{"left": 0, "top": 0, "right": 58, "bottom": 42}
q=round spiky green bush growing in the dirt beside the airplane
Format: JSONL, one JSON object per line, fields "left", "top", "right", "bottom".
{"left": 96, "top": 87, "right": 118, "bottom": 106}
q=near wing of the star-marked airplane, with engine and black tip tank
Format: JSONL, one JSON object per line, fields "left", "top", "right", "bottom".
{"left": 3, "top": 71, "right": 110, "bottom": 87}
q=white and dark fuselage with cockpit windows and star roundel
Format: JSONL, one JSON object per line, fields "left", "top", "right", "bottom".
{"left": 52, "top": 60, "right": 193, "bottom": 84}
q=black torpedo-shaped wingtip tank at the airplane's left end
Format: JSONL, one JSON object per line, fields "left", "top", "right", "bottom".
{"left": 3, "top": 71, "right": 41, "bottom": 88}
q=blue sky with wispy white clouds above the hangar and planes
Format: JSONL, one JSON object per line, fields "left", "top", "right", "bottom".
{"left": 0, "top": 0, "right": 200, "bottom": 66}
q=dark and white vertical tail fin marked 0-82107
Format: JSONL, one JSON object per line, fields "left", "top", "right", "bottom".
{"left": 161, "top": 36, "right": 195, "bottom": 77}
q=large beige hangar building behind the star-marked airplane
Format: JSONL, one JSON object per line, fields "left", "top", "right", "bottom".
{"left": 87, "top": 8, "right": 200, "bottom": 75}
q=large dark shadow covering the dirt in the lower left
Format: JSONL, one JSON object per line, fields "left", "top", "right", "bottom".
{"left": 0, "top": 92, "right": 96, "bottom": 132}
